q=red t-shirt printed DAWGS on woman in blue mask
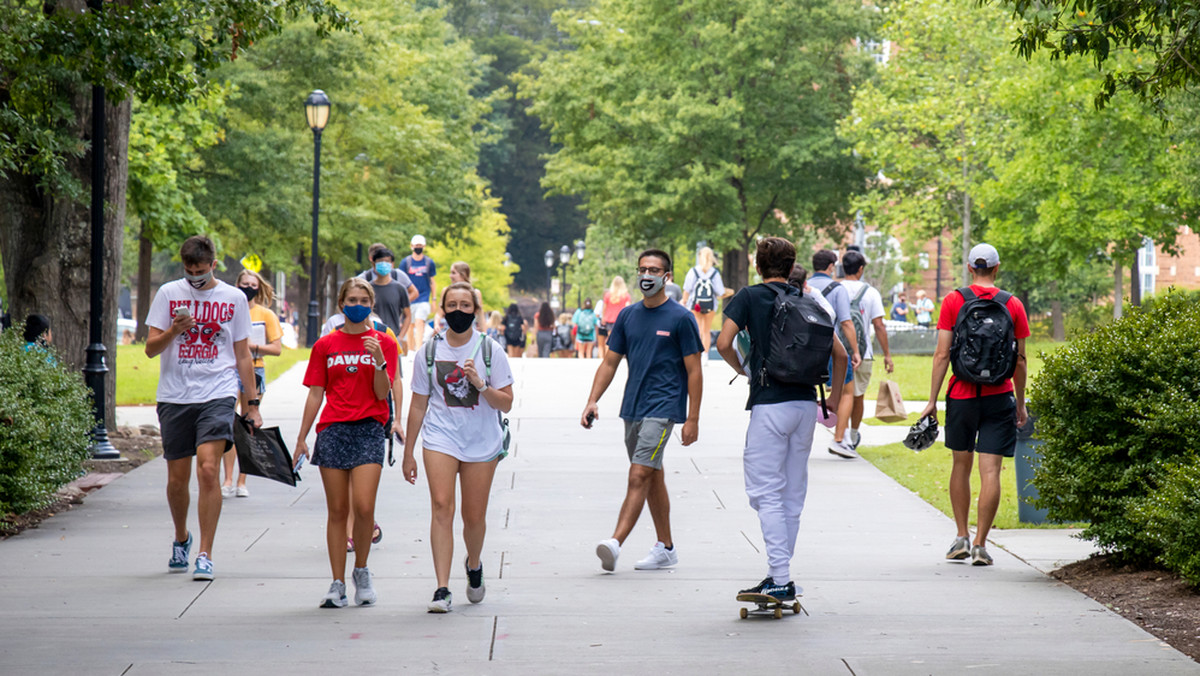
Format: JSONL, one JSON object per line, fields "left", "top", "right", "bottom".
{"left": 304, "top": 329, "right": 400, "bottom": 432}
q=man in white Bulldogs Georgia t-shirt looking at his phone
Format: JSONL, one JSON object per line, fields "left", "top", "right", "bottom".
{"left": 145, "top": 235, "right": 263, "bottom": 581}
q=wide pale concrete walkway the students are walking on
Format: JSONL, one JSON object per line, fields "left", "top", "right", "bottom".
{"left": 0, "top": 359, "right": 1185, "bottom": 676}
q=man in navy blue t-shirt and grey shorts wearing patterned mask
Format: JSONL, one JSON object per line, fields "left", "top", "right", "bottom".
{"left": 580, "top": 249, "right": 703, "bottom": 570}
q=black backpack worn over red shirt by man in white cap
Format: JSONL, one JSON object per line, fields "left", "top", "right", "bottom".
{"left": 950, "top": 287, "right": 1016, "bottom": 393}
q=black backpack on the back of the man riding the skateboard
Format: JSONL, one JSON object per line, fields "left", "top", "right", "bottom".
{"left": 758, "top": 285, "right": 833, "bottom": 385}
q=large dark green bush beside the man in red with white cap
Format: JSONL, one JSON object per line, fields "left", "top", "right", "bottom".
{"left": 1030, "top": 293, "right": 1200, "bottom": 561}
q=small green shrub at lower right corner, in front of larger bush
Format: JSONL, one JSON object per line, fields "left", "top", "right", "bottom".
{"left": 1130, "top": 457, "right": 1200, "bottom": 585}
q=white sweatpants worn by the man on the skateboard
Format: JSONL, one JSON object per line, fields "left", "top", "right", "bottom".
{"left": 742, "top": 401, "right": 817, "bottom": 585}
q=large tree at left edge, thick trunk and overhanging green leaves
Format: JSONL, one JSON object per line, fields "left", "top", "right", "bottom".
{"left": 0, "top": 0, "right": 350, "bottom": 425}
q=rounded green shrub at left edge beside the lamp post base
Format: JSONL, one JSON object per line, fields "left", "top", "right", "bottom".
{"left": 0, "top": 327, "right": 95, "bottom": 521}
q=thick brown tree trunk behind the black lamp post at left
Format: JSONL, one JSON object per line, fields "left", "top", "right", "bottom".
{"left": 0, "top": 85, "right": 131, "bottom": 430}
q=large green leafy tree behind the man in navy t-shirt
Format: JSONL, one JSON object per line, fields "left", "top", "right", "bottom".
{"left": 520, "top": 0, "right": 871, "bottom": 288}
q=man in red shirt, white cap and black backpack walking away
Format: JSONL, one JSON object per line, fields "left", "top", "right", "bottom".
{"left": 920, "top": 244, "right": 1030, "bottom": 566}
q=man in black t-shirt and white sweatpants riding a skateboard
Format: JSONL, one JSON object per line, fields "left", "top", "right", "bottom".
{"left": 716, "top": 237, "right": 847, "bottom": 602}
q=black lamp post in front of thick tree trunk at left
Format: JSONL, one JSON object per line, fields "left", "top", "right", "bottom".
{"left": 83, "top": 0, "right": 121, "bottom": 460}
